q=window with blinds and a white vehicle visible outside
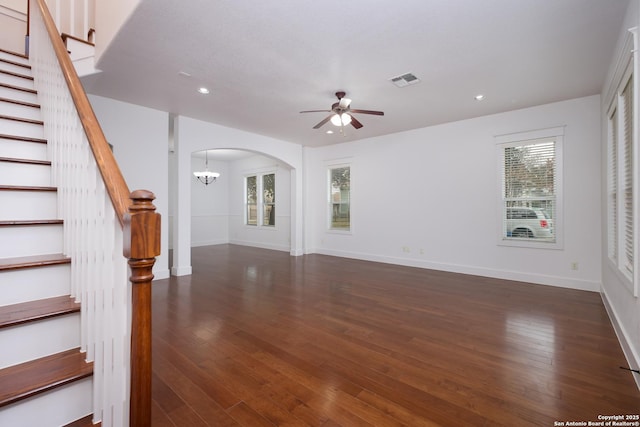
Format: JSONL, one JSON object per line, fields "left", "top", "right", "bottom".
{"left": 497, "top": 128, "right": 563, "bottom": 248}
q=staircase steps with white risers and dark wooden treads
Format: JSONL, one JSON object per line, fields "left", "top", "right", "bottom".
{"left": 0, "top": 50, "right": 93, "bottom": 427}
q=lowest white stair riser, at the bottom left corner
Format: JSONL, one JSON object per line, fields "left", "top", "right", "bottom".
{"left": 0, "top": 377, "right": 93, "bottom": 427}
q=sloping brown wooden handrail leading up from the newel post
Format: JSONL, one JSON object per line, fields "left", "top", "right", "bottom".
{"left": 36, "top": 0, "right": 131, "bottom": 225}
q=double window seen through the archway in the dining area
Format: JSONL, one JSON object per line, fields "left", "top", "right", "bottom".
{"left": 245, "top": 173, "right": 276, "bottom": 226}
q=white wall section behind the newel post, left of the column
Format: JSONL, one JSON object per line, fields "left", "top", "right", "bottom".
{"left": 89, "top": 95, "right": 169, "bottom": 279}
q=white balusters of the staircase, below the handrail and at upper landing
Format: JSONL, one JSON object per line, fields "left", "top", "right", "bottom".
{"left": 30, "top": 0, "right": 131, "bottom": 426}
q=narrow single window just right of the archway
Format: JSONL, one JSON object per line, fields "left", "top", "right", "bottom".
{"left": 329, "top": 166, "right": 351, "bottom": 231}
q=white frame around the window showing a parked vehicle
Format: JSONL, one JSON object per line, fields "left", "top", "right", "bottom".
{"left": 494, "top": 126, "right": 564, "bottom": 250}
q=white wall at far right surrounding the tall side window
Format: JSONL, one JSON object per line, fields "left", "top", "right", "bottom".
{"left": 601, "top": 0, "right": 640, "bottom": 388}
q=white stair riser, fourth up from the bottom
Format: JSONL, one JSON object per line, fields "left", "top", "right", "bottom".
{"left": 0, "top": 225, "right": 63, "bottom": 258}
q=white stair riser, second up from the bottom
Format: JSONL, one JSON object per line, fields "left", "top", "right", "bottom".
{"left": 0, "top": 313, "right": 80, "bottom": 370}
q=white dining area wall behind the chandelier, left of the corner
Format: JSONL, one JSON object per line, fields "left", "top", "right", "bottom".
{"left": 190, "top": 151, "right": 233, "bottom": 246}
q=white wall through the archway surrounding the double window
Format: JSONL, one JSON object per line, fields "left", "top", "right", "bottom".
{"left": 229, "top": 155, "right": 291, "bottom": 251}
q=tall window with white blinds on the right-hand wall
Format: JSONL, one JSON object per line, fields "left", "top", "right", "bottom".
{"left": 607, "top": 67, "right": 636, "bottom": 289}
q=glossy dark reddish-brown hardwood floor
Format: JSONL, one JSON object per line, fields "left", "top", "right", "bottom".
{"left": 153, "top": 245, "right": 640, "bottom": 427}
